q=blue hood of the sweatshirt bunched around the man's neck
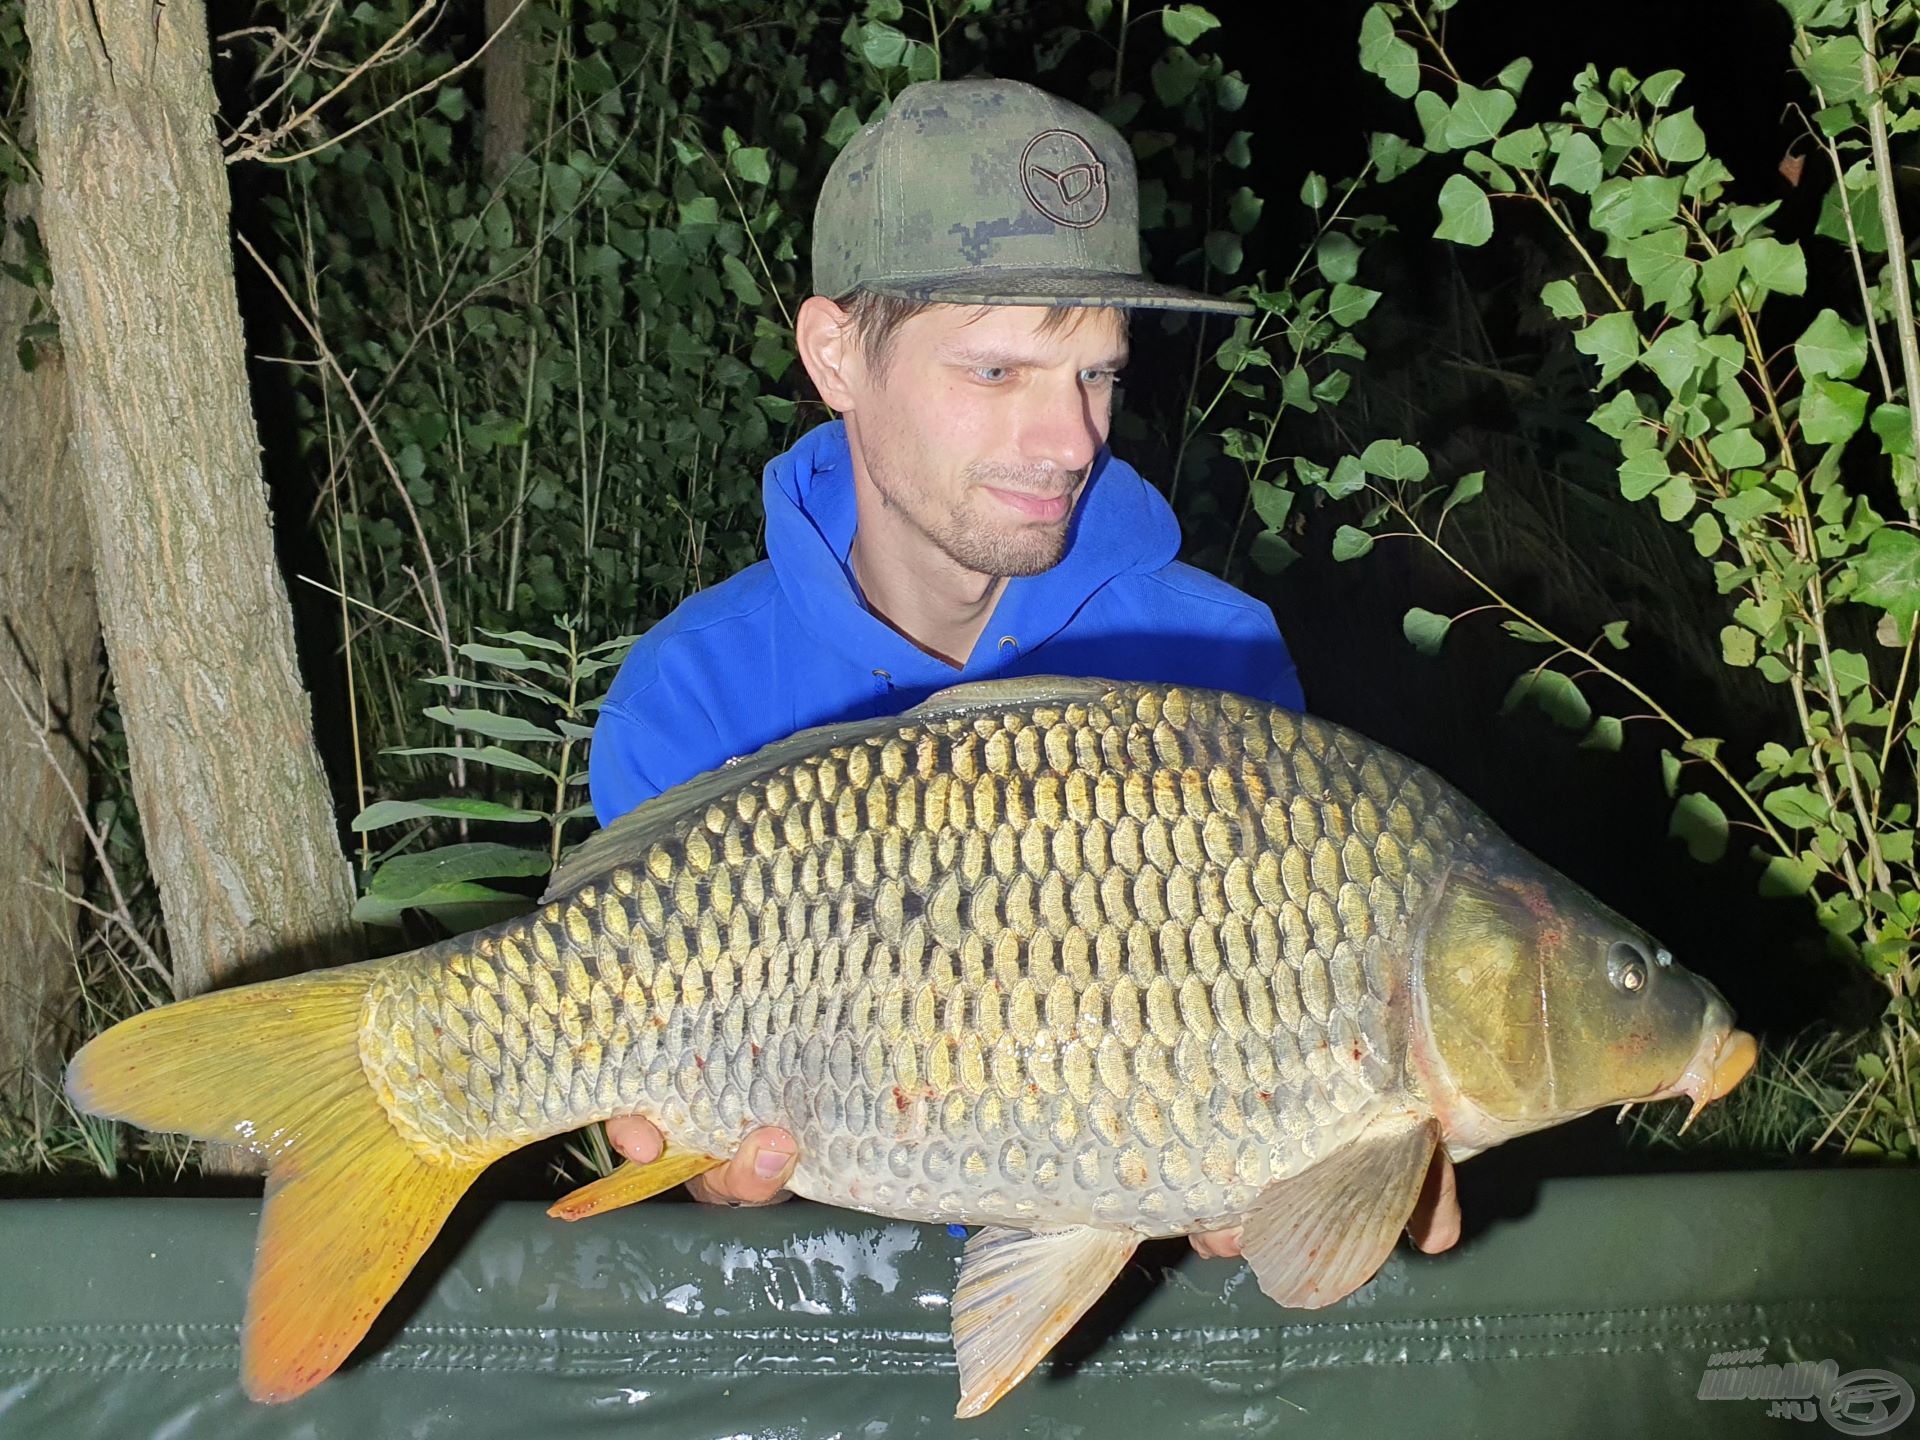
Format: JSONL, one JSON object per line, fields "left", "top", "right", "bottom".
{"left": 762, "top": 420, "right": 1181, "bottom": 687}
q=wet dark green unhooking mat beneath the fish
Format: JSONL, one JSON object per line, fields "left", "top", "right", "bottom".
{"left": 0, "top": 1171, "right": 1920, "bottom": 1440}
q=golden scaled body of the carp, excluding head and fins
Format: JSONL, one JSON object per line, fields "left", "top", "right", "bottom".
{"left": 361, "top": 685, "right": 1482, "bottom": 1235}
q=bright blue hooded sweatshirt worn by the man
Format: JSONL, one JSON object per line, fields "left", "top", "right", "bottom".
{"left": 589, "top": 420, "right": 1302, "bottom": 824}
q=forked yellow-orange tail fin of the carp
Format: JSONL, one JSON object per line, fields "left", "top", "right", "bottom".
{"left": 67, "top": 962, "right": 486, "bottom": 1400}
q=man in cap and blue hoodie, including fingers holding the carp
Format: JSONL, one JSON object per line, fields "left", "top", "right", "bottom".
{"left": 591, "top": 81, "right": 1457, "bottom": 1254}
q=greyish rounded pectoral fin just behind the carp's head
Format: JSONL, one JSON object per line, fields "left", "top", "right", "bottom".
{"left": 1240, "top": 1117, "right": 1440, "bottom": 1309}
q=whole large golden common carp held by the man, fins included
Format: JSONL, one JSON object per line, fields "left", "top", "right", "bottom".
{"left": 67, "top": 678, "right": 1755, "bottom": 1415}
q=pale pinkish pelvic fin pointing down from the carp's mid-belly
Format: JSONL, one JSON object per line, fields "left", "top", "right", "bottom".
{"left": 952, "top": 1225, "right": 1140, "bottom": 1419}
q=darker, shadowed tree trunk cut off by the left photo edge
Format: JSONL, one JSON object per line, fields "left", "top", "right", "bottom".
{"left": 0, "top": 101, "right": 100, "bottom": 1106}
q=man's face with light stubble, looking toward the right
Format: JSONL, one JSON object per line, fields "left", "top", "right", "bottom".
{"left": 847, "top": 305, "right": 1127, "bottom": 576}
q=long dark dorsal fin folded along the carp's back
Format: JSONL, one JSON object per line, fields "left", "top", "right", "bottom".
{"left": 540, "top": 676, "right": 1114, "bottom": 904}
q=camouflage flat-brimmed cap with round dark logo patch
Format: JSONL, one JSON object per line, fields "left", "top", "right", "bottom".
{"left": 814, "top": 81, "right": 1252, "bottom": 315}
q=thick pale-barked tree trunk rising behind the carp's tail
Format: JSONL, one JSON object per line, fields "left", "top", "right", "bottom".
{"left": 27, "top": 0, "right": 359, "bottom": 996}
